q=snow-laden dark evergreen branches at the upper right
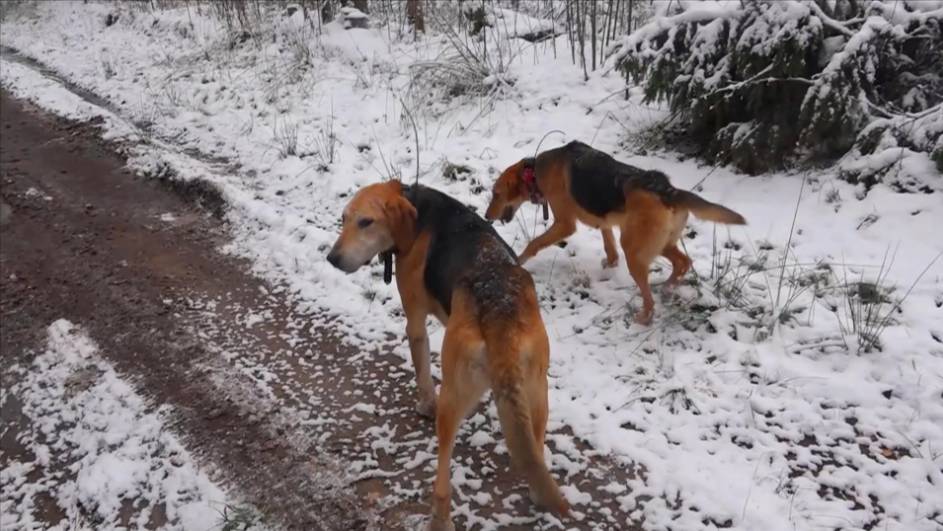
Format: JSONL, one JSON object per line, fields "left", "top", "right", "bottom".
{"left": 611, "top": 0, "right": 943, "bottom": 184}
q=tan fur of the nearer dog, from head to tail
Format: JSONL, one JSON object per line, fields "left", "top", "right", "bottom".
{"left": 332, "top": 181, "right": 569, "bottom": 529}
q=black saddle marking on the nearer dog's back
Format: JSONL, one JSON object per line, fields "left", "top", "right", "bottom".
{"left": 404, "top": 185, "right": 517, "bottom": 314}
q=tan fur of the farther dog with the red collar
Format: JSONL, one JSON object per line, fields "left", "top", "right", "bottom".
{"left": 485, "top": 150, "right": 745, "bottom": 324}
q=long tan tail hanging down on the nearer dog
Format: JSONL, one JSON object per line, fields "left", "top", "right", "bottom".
{"left": 487, "top": 334, "right": 570, "bottom": 516}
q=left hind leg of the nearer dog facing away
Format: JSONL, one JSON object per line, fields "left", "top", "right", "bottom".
{"left": 428, "top": 296, "right": 489, "bottom": 531}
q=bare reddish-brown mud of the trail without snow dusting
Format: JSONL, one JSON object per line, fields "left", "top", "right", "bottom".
{"left": 0, "top": 94, "right": 367, "bottom": 529}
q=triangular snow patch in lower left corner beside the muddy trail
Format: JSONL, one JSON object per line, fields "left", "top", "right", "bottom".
{"left": 0, "top": 319, "right": 247, "bottom": 530}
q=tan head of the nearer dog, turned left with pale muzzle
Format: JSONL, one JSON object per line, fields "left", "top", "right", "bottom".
{"left": 327, "top": 181, "right": 416, "bottom": 273}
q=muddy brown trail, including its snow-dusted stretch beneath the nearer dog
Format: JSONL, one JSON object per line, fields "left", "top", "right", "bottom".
{"left": 0, "top": 94, "right": 634, "bottom": 529}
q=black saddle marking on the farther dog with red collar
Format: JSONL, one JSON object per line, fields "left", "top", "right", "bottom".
{"left": 540, "top": 141, "right": 675, "bottom": 217}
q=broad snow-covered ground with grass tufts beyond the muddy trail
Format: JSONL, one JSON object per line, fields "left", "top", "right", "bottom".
{"left": 0, "top": 2, "right": 943, "bottom": 531}
